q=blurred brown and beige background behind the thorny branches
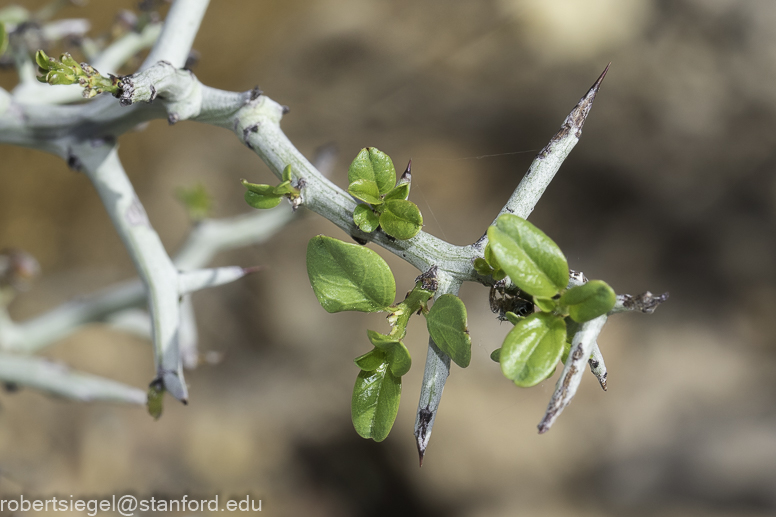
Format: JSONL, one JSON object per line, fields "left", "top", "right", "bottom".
{"left": 0, "top": 0, "right": 776, "bottom": 517}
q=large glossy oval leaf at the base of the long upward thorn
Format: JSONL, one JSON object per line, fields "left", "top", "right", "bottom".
{"left": 488, "top": 214, "right": 569, "bottom": 298}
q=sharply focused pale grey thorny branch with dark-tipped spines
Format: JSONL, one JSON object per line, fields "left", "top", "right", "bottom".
{"left": 0, "top": 0, "right": 667, "bottom": 461}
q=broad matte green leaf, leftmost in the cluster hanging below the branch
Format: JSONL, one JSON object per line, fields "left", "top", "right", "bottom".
{"left": 307, "top": 235, "right": 396, "bottom": 312}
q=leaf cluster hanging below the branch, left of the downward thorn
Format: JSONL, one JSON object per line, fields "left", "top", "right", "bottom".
{"left": 307, "top": 235, "right": 471, "bottom": 442}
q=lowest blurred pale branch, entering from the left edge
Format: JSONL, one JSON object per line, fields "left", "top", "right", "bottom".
{"left": 0, "top": 353, "right": 146, "bottom": 405}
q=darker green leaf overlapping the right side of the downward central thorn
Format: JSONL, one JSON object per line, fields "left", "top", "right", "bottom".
{"left": 426, "top": 294, "right": 472, "bottom": 368}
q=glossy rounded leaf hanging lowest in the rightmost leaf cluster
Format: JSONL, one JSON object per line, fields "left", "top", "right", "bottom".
{"left": 500, "top": 312, "right": 566, "bottom": 388}
